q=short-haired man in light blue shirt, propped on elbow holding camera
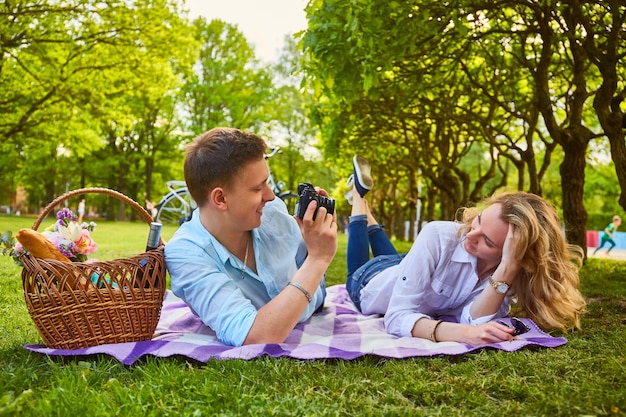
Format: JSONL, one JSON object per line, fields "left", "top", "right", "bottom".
{"left": 165, "top": 128, "right": 337, "bottom": 346}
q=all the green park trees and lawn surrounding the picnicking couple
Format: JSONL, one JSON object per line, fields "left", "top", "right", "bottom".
{"left": 0, "top": 0, "right": 626, "bottom": 416}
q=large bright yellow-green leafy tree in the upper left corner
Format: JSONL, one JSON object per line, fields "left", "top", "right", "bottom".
{"left": 0, "top": 0, "right": 194, "bottom": 211}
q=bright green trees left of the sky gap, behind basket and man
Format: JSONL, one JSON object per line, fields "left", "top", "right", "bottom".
{"left": 0, "top": 0, "right": 330, "bottom": 219}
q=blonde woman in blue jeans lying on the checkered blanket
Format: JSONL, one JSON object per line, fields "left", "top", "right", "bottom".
{"left": 346, "top": 156, "right": 585, "bottom": 345}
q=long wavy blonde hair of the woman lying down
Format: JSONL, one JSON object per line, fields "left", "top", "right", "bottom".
{"left": 459, "top": 192, "right": 586, "bottom": 330}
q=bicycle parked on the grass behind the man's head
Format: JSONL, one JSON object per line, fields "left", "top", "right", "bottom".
{"left": 154, "top": 147, "right": 299, "bottom": 226}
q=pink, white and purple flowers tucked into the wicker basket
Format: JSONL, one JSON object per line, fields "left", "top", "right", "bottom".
{"left": 2, "top": 208, "right": 98, "bottom": 265}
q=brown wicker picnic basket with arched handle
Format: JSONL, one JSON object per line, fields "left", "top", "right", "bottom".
{"left": 20, "top": 188, "right": 166, "bottom": 349}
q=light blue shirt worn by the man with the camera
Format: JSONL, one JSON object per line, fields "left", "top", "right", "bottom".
{"left": 165, "top": 198, "right": 325, "bottom": 346}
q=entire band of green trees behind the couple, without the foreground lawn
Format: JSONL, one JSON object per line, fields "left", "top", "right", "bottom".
{"left": 0, "top": 0, "right": 626, "bottom": 256}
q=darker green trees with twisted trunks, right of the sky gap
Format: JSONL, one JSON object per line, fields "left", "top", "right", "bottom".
{"left": 302, "top": 0, "right": 626, "bottom": 244}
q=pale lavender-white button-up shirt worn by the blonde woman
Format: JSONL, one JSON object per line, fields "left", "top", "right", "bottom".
{"left": 361, "top": 221, "right": 511, "bottom": 337}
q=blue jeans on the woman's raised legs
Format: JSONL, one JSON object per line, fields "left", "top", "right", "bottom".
{"left": 346, "top": 214, "right": 404, "bottom": 311}
